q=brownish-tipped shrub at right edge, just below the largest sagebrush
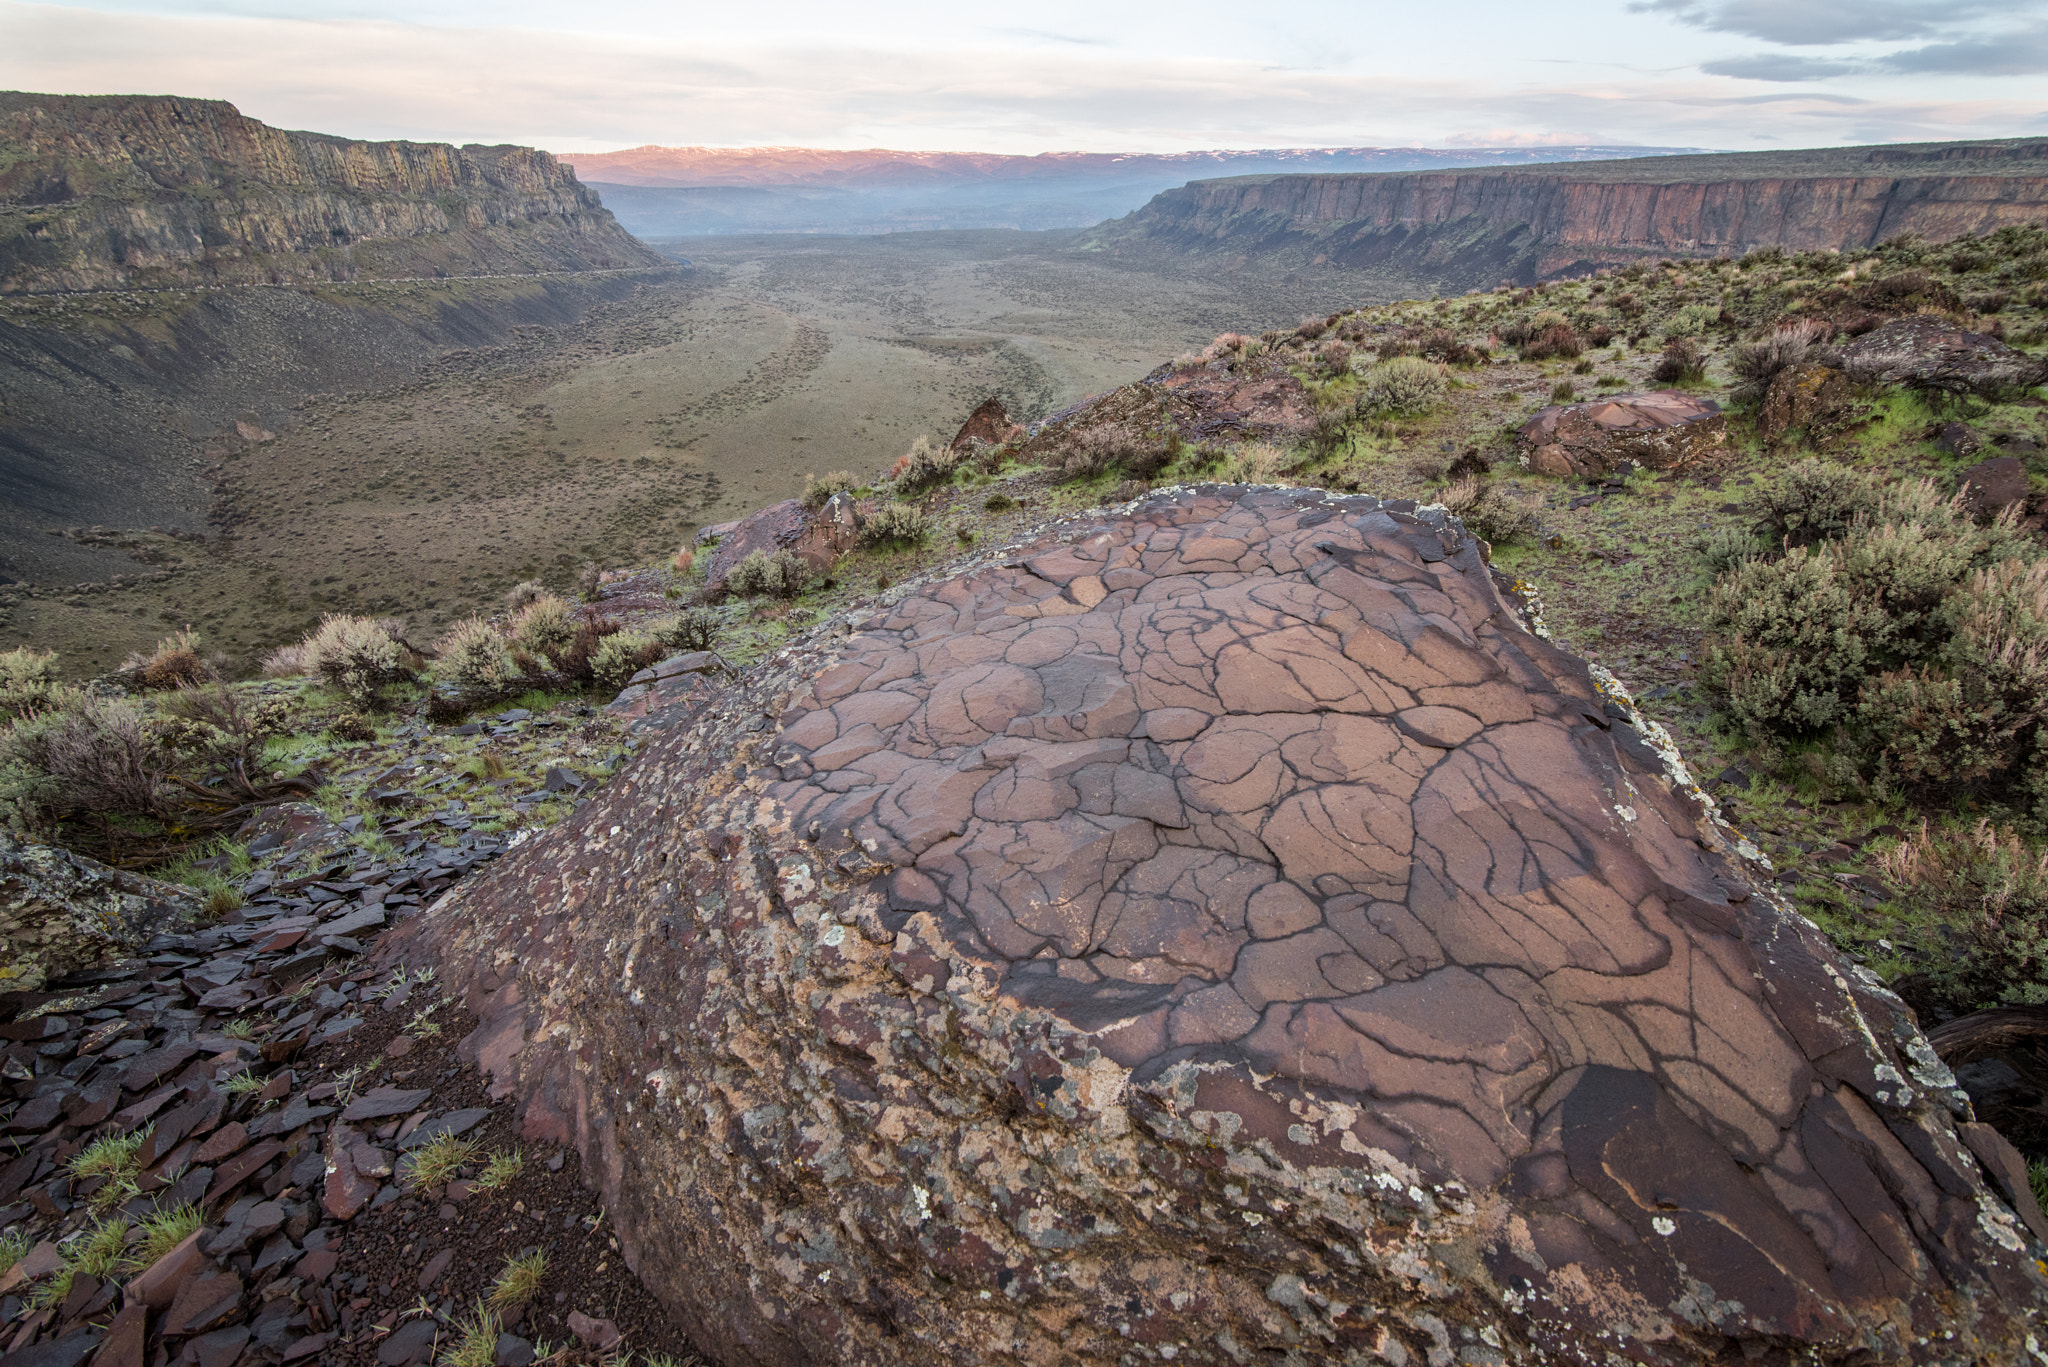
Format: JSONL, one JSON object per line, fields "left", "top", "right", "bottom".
{"left": 1880, "top": 820, "right": 2048, "bottom": 1010}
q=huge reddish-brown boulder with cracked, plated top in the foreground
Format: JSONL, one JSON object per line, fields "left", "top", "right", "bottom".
{"left": 393, "top": 486, "right": 2048, "bottom": 1367}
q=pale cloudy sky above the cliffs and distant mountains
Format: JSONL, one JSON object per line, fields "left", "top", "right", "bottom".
{"left": 0, "top": 0, "right": 2048, "bottom": 154}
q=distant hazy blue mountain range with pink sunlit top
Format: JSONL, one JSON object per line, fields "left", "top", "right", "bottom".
{"left": 559, "top": 148, "right": 1698, "bottom": 238}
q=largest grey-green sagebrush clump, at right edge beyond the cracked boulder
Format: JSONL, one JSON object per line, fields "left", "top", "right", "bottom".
{"left": 1706, "top": 475, "right": 2048, "bottom": 816}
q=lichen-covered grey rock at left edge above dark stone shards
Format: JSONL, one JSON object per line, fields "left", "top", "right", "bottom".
{"left": 0, "top": 830, "right": 201, "bottom": 992}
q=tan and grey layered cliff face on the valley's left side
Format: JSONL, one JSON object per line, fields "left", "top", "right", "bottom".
{"left": 0, "top": 92, "right": 664, "bottom": 293}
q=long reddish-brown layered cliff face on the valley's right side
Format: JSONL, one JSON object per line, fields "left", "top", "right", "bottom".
{"left": 1096, "top": 141, "right": 2048, "bottom": 285}
